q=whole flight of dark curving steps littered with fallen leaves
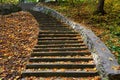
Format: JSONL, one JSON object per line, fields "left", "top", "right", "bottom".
{"left": 22, "top": 12, "right": 99, "bottom": 80}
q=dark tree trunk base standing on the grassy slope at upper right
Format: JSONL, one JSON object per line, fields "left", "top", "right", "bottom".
{"left": 96, "top": 0, "right": 106, "bottom": 15}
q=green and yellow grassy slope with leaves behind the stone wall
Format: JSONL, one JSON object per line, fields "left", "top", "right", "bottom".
{"left": 38, "top": 0, "right": 120, "bottom": 63}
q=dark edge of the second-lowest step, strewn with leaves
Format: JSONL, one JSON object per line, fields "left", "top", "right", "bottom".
{"left": 26, "top": 63, "right": 95, "bottom": 69}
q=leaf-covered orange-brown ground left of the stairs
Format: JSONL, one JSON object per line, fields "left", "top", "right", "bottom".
{"left": 0, "top": 11, "right": 39, "bottom": 80}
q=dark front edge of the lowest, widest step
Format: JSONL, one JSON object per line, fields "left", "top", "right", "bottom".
{"left": 22, "top": 71, "right": 98, "bottom": 77}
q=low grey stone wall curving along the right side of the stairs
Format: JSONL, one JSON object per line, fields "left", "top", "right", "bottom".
{"left": 33, "top": 5, "right": 120, "bottom": 80}
